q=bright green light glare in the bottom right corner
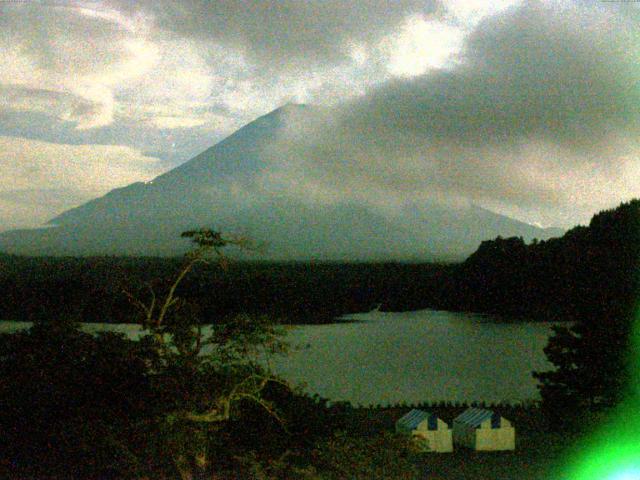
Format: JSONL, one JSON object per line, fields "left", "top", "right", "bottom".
{"left": 556, "top": 307, "right": 640, "bottom": 480}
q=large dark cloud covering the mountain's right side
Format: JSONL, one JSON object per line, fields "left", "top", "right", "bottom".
{"left": 268, "top": 2, "right": 640, "bottom": 227}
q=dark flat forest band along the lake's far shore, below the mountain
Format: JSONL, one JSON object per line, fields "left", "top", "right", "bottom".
{"left": 0, "top": 255, "right": 451, "bottom": 323}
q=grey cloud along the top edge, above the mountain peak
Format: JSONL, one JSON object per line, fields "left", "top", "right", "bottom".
{"left": 109, "top": 0, "right": 438, "bottom": 70}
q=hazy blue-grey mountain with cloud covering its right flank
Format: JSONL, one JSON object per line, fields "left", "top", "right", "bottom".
{"left": 0, "top": 105, "right": 561, "bottom": 260}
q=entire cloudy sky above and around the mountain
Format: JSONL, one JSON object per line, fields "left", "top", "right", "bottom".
{"left": 0, "top": 0, "right": 640, "bottom": 230}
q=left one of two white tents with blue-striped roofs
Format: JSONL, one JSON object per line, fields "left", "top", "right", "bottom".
{"left": 396, "top": 409, "right": 453, "bottom": 452}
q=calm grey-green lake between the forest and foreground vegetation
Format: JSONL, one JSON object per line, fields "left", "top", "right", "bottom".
{"left": 0, "top": 310, "right": 552, "bottom": 405}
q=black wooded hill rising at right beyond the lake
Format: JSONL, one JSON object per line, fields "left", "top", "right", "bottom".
{"left": 438, "top": 200, "right": 640, "bottom": 320}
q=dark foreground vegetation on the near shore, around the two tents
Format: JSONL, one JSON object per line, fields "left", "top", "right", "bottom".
{"left": 0, "top": 316, "right": 594, "bottom": 480}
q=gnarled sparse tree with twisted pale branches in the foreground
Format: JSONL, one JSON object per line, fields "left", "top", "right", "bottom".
{"left": 125, "top": 229, "right": 286, "bottom": 480}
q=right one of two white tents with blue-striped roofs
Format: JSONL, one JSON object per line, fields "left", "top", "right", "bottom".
{"left": 453, "top": 408, "right": 516, "bottom": 450}
